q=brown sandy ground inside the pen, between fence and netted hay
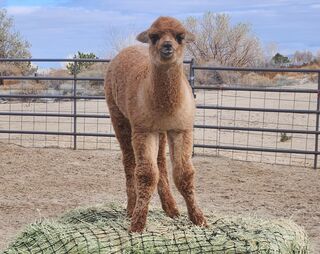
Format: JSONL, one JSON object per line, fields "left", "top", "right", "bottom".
{"left": 0, "top": 143, "right": 320, "bottom": 253}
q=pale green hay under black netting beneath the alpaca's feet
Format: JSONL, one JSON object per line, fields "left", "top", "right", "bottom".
{"left": 4, "top": 206, "right": 308, "bottom": 254}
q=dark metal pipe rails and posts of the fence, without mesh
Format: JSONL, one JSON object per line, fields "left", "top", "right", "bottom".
{"left": 0, "top": 58, "right": 320, "bottom": 168}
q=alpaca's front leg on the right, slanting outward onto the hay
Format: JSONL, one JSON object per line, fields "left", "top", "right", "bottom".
{"left": 168, "top": 130, "right": 207, "bottom": 226}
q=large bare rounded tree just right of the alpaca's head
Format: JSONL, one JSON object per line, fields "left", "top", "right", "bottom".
{"left": 185, "top": 12, "right": 263, "bottom": 67}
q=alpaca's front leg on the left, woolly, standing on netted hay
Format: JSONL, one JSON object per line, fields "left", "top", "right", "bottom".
{"left": 129, "top": 133, "right": 159, "bottom": 232}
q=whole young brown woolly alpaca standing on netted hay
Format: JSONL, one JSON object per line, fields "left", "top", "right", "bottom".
{"left": 105, "top": 17, "right": 206, "bottom": 232}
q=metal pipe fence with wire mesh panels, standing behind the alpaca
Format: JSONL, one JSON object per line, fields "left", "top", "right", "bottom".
{"left": 0, "top": 59, "right": 320, "bottom": 168}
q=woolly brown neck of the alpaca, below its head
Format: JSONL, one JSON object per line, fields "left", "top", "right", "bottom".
{"left": 151, "top": 63, "right": 183, "bottom": 114}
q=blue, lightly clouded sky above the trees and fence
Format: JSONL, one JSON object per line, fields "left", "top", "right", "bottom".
{"left": 0, "top": 0, "right": 320, "bottom": 67}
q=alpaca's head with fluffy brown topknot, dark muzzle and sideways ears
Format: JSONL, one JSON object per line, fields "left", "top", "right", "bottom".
{"left": 137, "top": 17, "right": 195, "bottom": 65}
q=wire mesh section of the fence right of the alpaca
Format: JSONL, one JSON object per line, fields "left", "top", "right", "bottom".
{"left": 191, "top": 75, "right": 318, "bottom": 166}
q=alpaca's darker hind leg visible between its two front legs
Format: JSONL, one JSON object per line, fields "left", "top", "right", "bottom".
{"left": 158, "top": 133, "right": 180, "bottom": 218}
